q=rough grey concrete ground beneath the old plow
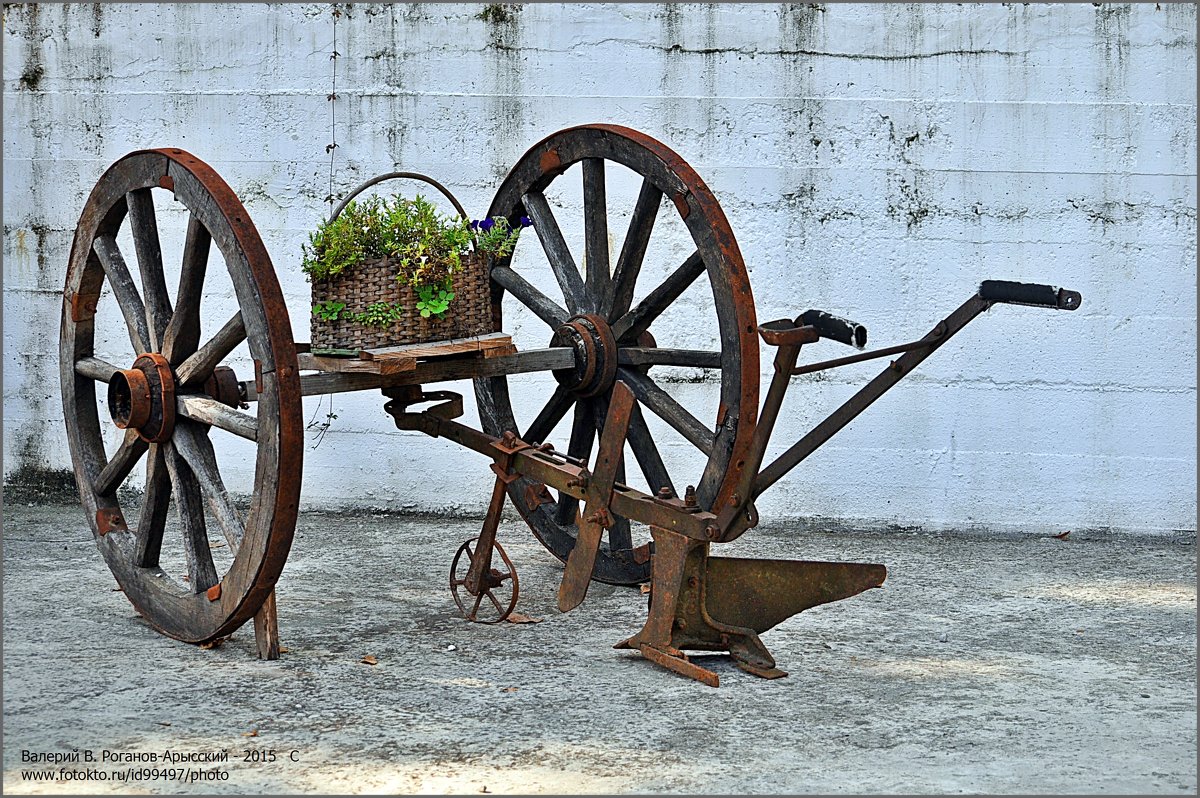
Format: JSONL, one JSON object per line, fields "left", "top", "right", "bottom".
{"left": 4, "top": 504, "right": 1196, "bottom": 793}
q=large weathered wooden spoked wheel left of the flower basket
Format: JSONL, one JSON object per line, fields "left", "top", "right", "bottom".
{"left": 60, "top": 149, "right": 304, "bottom": 642}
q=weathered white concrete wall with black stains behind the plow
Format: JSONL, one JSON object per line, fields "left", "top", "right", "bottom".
{"left": 4, "top": 4, "right": 1196, "bottom": 532}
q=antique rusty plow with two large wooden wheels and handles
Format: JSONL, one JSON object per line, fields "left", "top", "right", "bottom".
{"left": 60, "top": 125, "right": 1080, "bottom": 685}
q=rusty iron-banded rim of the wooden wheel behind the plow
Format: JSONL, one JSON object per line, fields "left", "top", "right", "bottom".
{"left": 475, "top": 125, "right": 758, "bottom": 584}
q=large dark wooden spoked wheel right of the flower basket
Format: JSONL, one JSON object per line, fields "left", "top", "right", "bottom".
{"left": 475, "top": 125, "right": 758, "bottom": 584}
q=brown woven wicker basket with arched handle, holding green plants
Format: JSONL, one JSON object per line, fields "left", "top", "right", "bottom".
{"left": 311, "top": 172, "right": 496, "bottom": 350}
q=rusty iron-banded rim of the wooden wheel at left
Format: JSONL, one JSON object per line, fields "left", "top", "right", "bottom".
{"left": 60, "top": 149, "right": 304, "bottom": 642}
